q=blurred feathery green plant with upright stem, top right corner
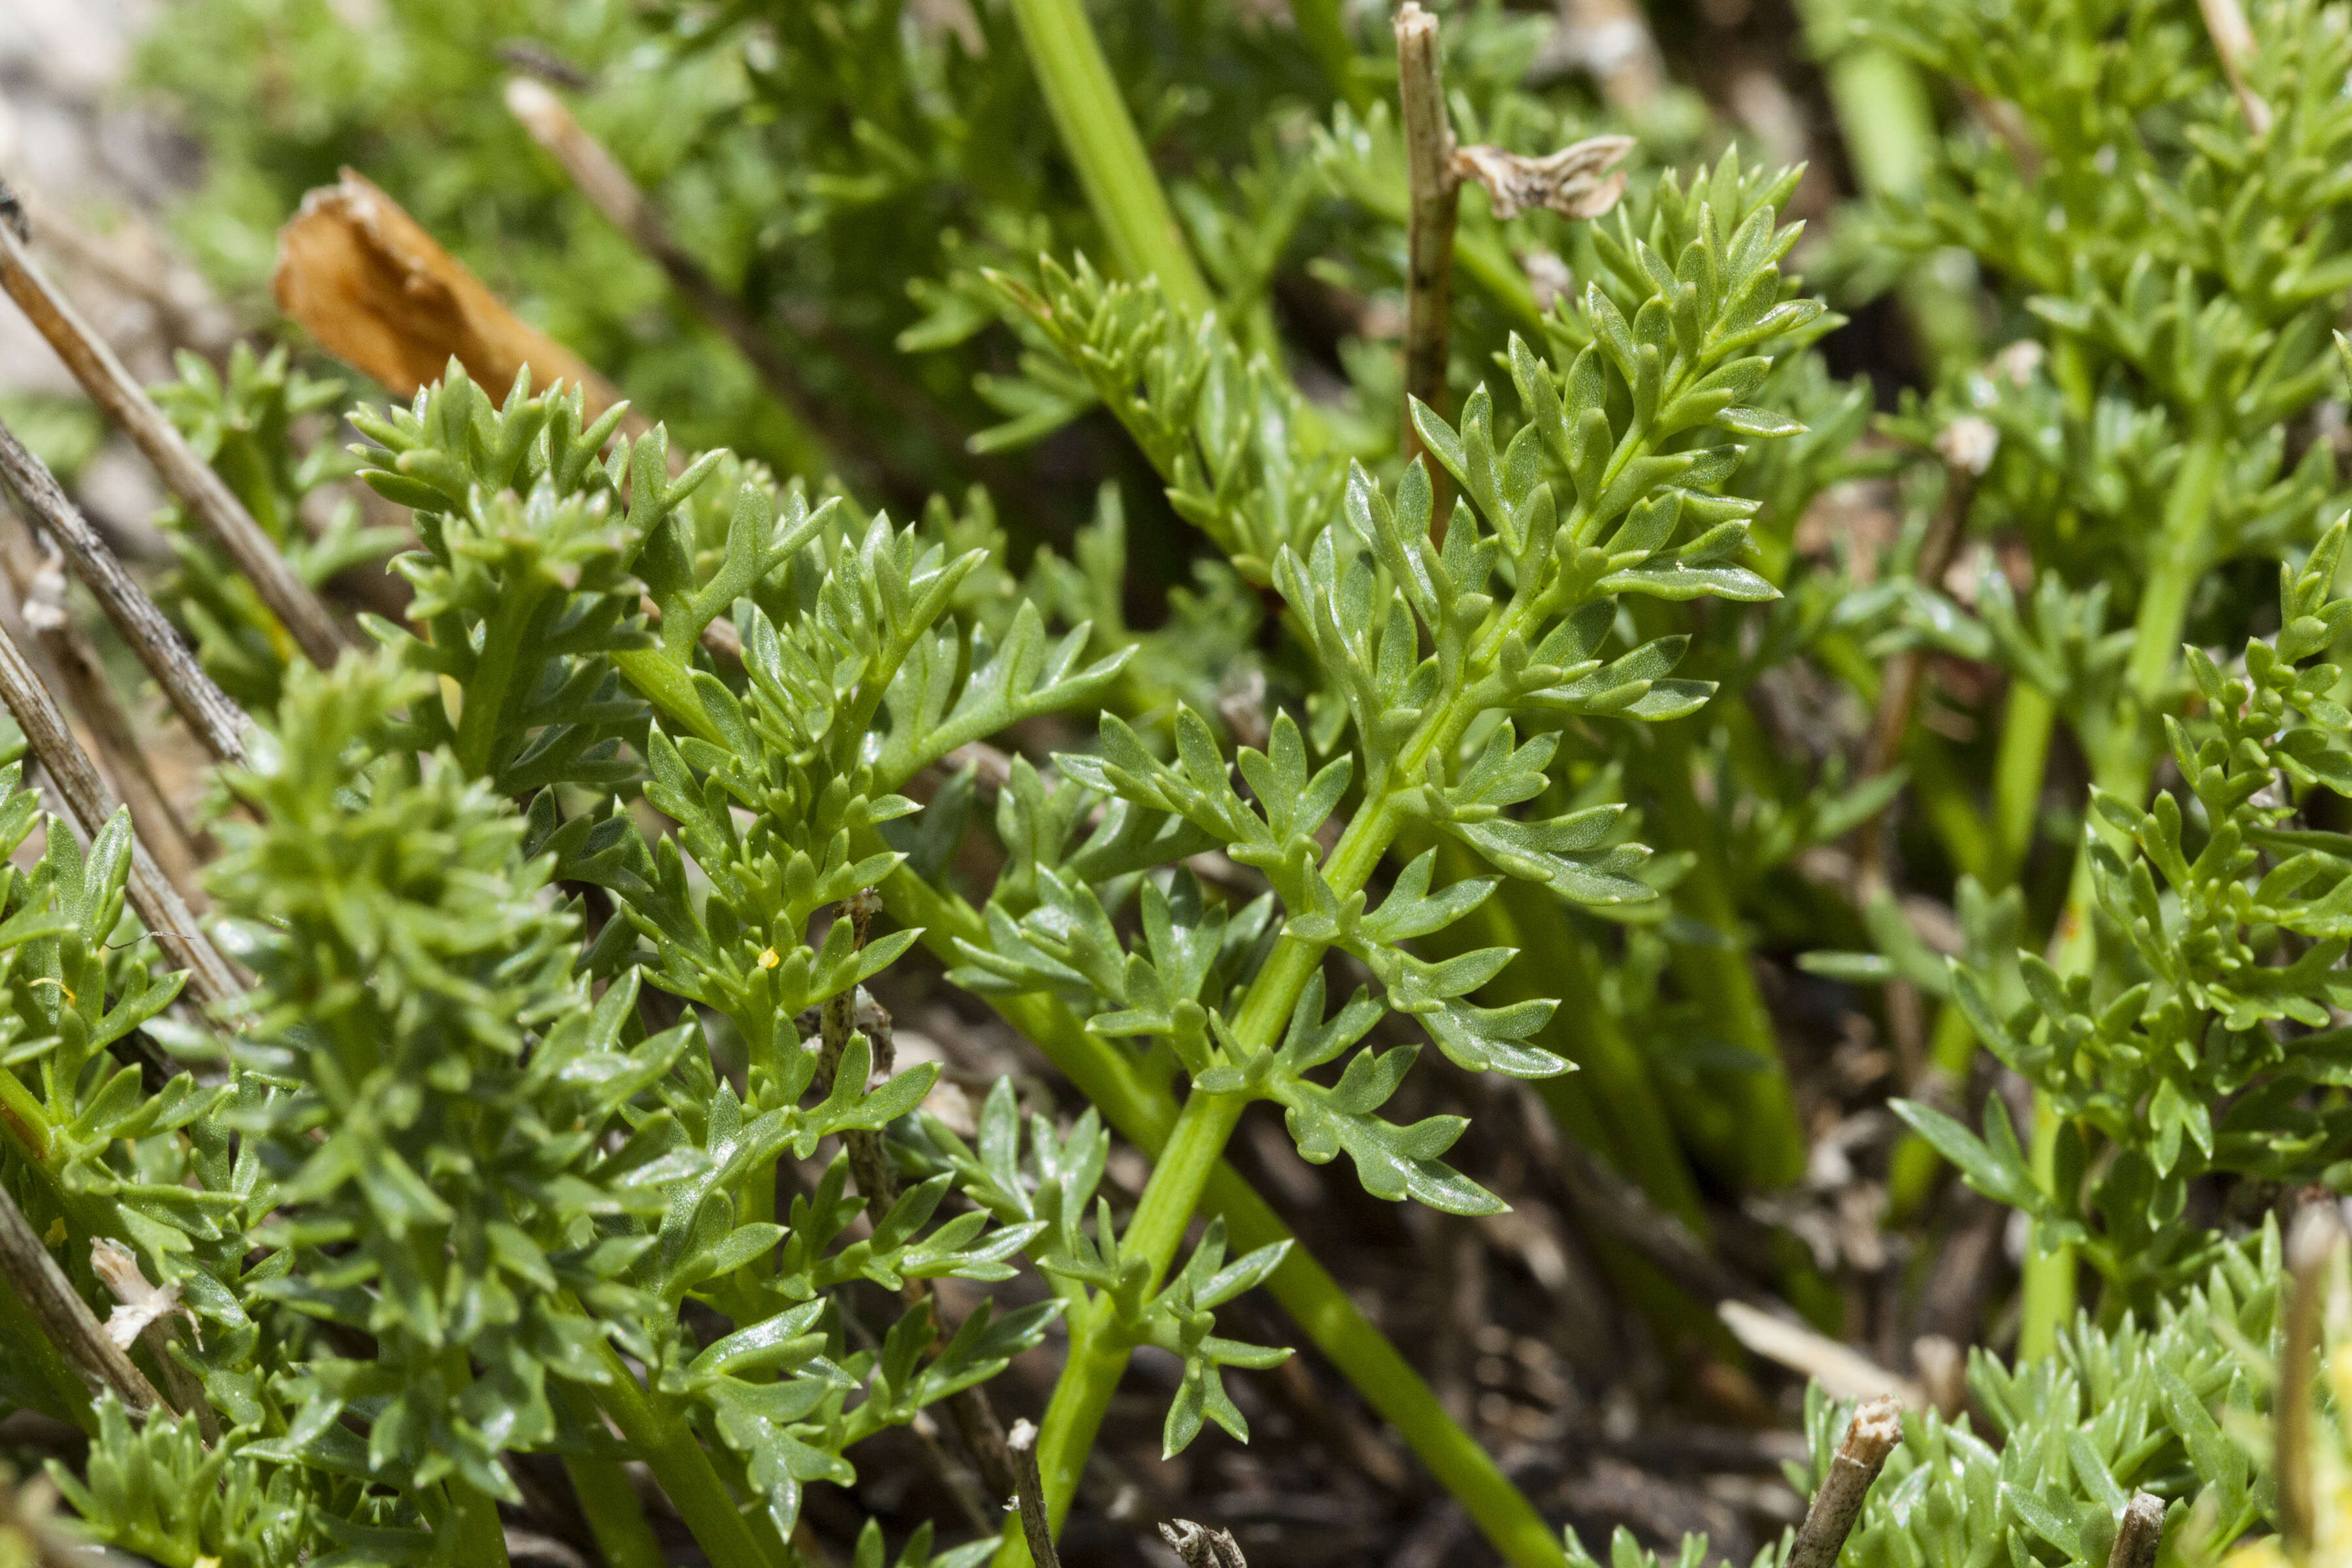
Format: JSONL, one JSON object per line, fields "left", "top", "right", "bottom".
{"left": 1858, "top": 3, "right": 2352, "bottom": 1349}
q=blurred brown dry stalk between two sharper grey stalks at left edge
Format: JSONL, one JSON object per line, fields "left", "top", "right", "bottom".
{"left": 0, "top": 519, "right": 207, "bottom": 910}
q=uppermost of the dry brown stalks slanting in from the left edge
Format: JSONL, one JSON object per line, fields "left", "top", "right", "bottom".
{"left": 0, "top": 197, "right": 344, "bottom": 670}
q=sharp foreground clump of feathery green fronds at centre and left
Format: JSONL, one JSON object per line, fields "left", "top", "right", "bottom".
{"left": 27, "top": 131, "right": 1818, "bottom": 1563}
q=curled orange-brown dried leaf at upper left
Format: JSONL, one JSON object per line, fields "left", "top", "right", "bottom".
{"left": 270, "top": 169, "right": 625, "bottom": 416}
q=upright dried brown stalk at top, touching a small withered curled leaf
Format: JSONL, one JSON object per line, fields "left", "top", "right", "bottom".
{"left": 1397, "top": 0, "right": 1461, "bottom": 472}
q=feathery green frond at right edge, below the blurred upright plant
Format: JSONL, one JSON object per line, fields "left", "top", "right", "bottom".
{"left": 1896, "top": 522, "right": 2352, "bottom": 1321}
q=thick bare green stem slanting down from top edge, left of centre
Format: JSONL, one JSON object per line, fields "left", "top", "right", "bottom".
{"left": 1014, "top": 0, "right": 1216, "bottom": 315}
